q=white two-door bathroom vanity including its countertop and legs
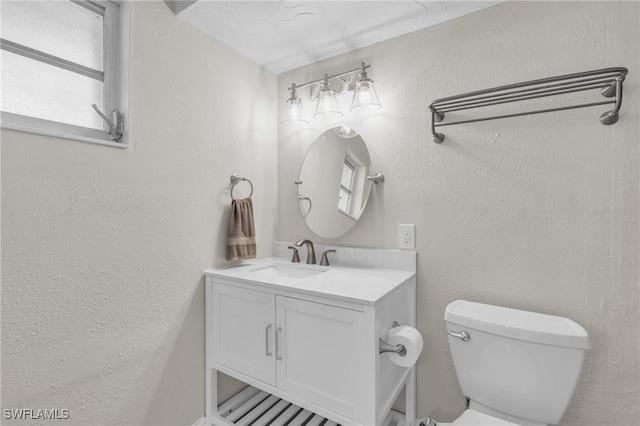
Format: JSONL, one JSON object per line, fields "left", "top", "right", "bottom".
{"left": 205, "top": 256, "right": 415, "bottom": 426}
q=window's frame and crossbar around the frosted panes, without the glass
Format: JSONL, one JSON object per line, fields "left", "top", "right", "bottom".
{"left": 0, "top": 0, "right": 131, "bottom": 148}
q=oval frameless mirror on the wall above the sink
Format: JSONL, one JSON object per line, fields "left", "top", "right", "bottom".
{"left": 297, "top": 127, "right": 372, "bottom": 238}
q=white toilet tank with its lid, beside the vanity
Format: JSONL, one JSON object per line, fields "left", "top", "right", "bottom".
{"left": 444, "top": 300, "right": 590, "bottom": 425}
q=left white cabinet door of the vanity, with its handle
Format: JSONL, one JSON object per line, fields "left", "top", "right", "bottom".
{"left": 213, "top": 283, "right": 276, "bottom": 386}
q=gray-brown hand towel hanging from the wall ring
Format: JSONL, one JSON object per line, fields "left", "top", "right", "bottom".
{"left": 226, "top": 198, "right": 256, "bottom": 260}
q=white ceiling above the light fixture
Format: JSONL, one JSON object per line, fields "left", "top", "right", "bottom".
{"left": 174, "top": 0, "right": 501, "bottom": 74}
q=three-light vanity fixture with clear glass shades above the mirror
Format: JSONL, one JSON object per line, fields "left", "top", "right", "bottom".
{"left": 281, "top": 62, "right": 382, "bottom": 124}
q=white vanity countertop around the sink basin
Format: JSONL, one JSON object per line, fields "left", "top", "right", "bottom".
{"left": 205, "top": 257, "right": 415, "bottom": 305}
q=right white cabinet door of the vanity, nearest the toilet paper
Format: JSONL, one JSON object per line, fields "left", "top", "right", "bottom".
{"left": 276, "top": 296, "right": 365, "bottom": 418}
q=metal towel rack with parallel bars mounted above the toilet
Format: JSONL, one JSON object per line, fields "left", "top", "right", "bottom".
{"left": 429, "top": 67, "right": 628, "bottom": 143}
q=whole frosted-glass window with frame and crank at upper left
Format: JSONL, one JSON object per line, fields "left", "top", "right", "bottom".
{"left": 0, "top": 0, "right": 128, "bottom": 146}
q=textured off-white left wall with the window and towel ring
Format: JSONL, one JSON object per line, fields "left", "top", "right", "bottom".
{"left": 1, "top": 2, "right": 277, "bottom": 425}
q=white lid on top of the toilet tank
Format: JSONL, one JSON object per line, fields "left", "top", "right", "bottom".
{"left": 444, "top": 300, "right": 591, "bottom": 349}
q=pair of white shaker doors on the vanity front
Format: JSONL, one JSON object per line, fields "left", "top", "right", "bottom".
{"left": 211, "top": 281, "right": 367, "bottom": 418}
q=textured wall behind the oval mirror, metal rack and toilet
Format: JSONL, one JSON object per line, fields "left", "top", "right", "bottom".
{"left": 277, "top": 2, "right": 640, "bottom": 426}
